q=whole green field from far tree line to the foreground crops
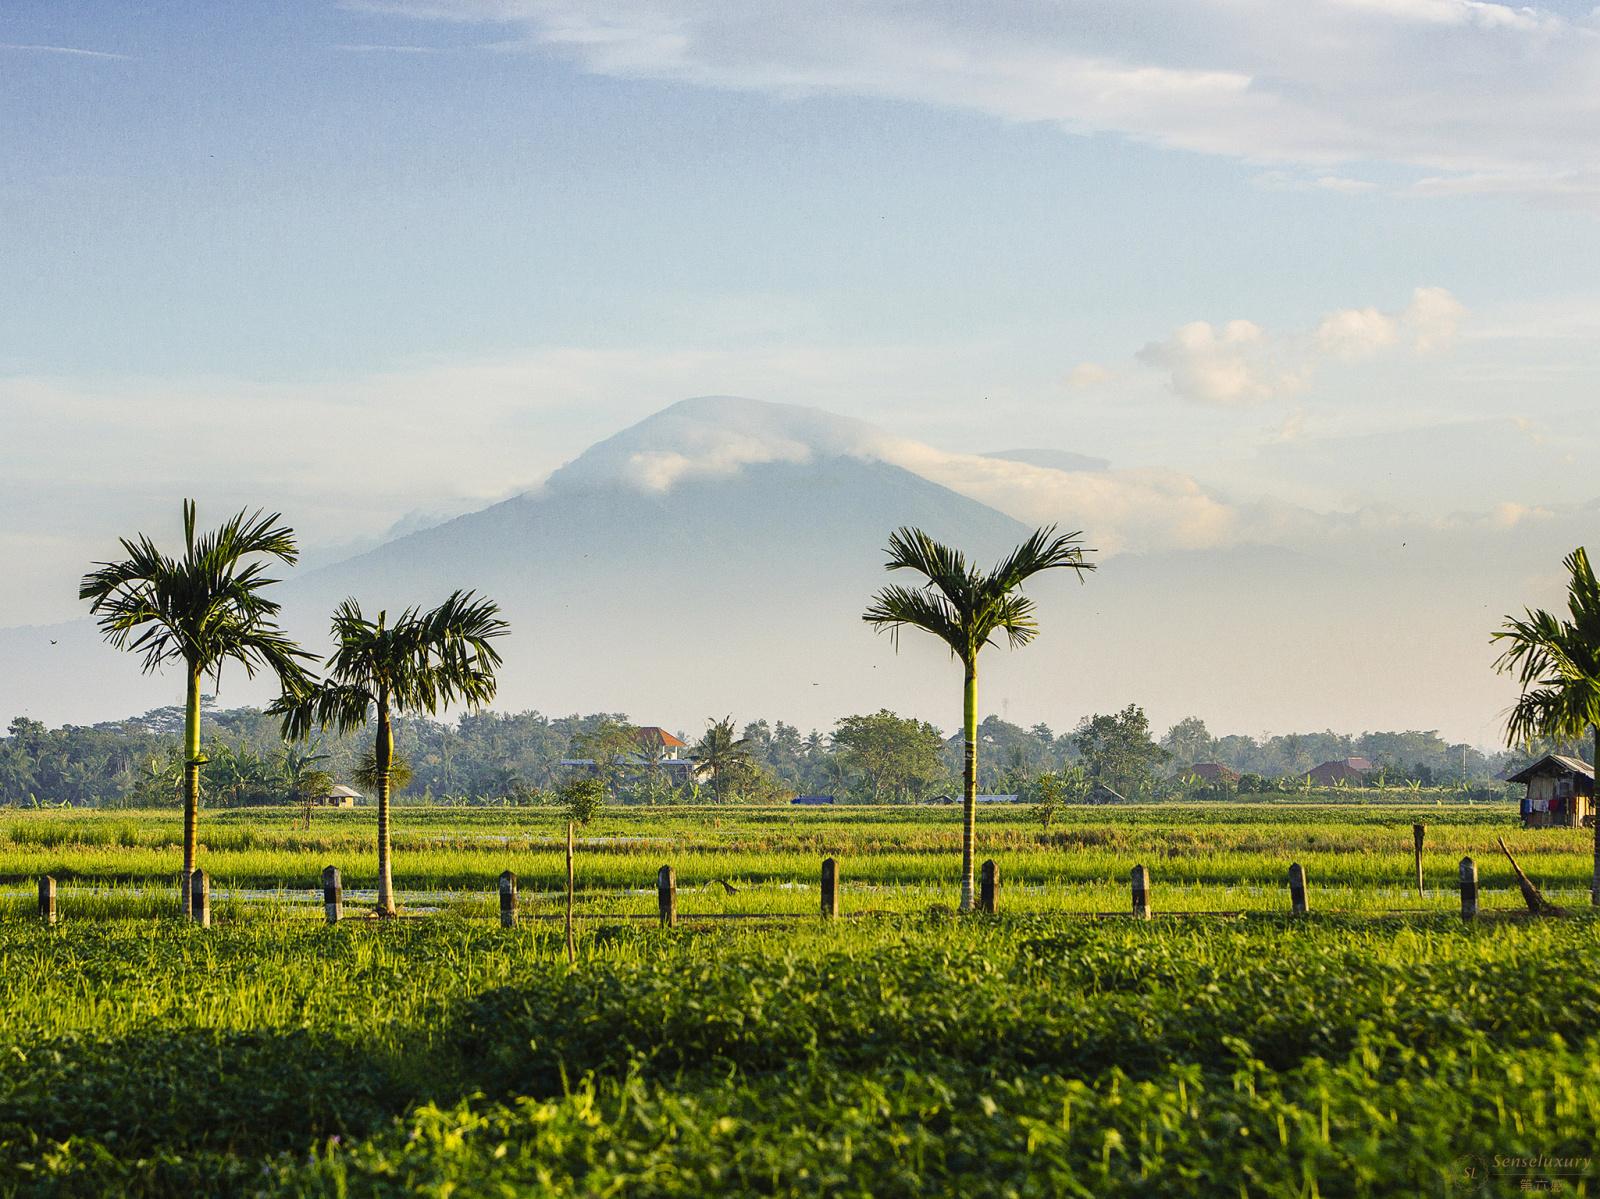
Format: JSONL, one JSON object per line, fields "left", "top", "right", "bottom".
{"left": 0, "top": 805, "right": 1600, "bottom": 1196}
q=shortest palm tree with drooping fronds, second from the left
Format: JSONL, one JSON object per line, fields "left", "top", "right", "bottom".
{"left": 267, "top": 591, "right": 509, "bottom": 916}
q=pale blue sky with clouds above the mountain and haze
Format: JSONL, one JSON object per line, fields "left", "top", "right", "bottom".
{"left": 0, "top": 0, "right": 1600, "bottom": 741}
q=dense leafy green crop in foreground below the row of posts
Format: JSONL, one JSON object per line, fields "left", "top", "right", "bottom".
{"left": 9, "top": 916, "right": 1600, "bottom": 1199}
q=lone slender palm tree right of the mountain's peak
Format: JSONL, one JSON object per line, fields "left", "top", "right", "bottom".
{"left": 862, "top": 525, "right": 1094, "bottom": 912}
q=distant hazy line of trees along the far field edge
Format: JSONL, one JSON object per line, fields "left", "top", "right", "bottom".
{"left": 0, "top": 704, "right": 1592, "bottom": 807}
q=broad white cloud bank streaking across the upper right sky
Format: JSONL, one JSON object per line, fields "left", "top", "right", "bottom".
{"left": 352, "top": 0, "right": 1600, "bottom": 203}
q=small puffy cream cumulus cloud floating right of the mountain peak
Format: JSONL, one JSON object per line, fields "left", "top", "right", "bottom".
{"left": 1136, "top": 287, "right": 1467, "bottom": 407}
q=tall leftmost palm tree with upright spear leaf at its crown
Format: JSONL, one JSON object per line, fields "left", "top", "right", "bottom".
{"left": 78, "top": 499, "right": 310, "bottom": 911}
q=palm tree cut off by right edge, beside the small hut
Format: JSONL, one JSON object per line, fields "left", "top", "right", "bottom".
{"left": 1493, "top": 546, "right": 1600, "bottom": 906}
